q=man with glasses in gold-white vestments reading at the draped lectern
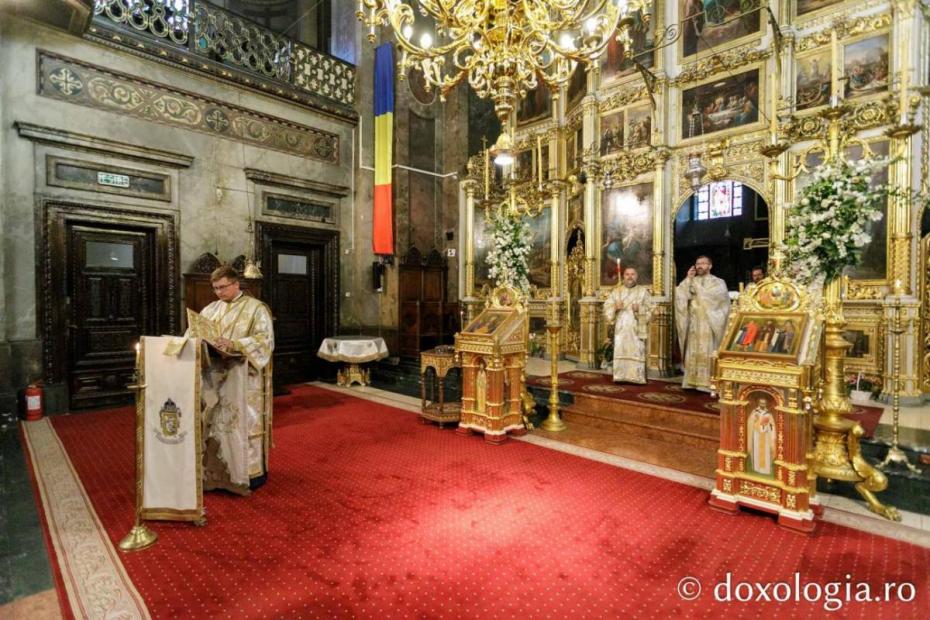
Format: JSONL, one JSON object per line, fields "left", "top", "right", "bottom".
{"left": 187, "top": 266, "right": 274, "bottom": 495}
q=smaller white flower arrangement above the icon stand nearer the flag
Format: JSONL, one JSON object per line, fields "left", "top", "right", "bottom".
{"left": 487, "top": 208, "right": 532, "bottom": 294}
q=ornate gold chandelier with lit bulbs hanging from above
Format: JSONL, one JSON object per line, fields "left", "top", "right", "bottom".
{"left": 357, "top": 0, "right": 640, "bottom": 122}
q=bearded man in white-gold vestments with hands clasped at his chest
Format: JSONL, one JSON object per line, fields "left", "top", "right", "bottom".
{"left": 604, "top": 267, "right": 652, "bottom": 383}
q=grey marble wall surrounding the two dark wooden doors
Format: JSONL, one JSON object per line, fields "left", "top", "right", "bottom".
{"left": 0, "top": 15, "right": 362, "bottom": 409}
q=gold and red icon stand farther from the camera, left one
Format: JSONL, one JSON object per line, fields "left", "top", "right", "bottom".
{"left": 455, "top": 287, "right": 527, "bottom": 443}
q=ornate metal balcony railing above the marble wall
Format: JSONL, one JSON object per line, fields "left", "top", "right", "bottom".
{"left": 88, "top": 0, "right": 355, "bottom": 116}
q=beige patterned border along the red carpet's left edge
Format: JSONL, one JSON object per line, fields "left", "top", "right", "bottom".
{"left": 23, "top": 418, "right": 150, "bottom": 620}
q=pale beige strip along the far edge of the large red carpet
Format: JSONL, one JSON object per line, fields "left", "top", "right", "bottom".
{"left": 314, "top": 382, "right": 930, "bottom": 547}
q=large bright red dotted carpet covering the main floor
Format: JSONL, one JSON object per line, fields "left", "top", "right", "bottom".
{"left": 41, "top": 386, "right": 930, "bottom": 618}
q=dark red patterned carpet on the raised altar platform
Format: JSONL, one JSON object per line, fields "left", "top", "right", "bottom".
{"left": 527, "top": 370, "right": 882, "bottom": 438}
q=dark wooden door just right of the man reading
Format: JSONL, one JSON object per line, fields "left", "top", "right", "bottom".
{"left": 269, "top": 241, "right": 331, "bottom": 384}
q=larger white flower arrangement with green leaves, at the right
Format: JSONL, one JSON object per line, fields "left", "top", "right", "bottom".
{"left": 785, "top": 159, "right": 895, "bottom": 284}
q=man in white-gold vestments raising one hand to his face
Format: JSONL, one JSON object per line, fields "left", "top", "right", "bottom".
{"left": 675, "top": 256, "right": 730, "bottom": 392}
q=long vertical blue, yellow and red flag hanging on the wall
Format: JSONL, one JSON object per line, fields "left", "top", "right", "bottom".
{"left": 371, "top": 43, "right": 394, "bottom": 254}
